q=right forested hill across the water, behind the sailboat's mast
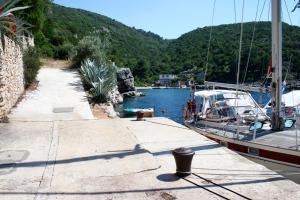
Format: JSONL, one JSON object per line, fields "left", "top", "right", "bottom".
{"left": 167, "top": 22, "right": 300, "bottom": 82}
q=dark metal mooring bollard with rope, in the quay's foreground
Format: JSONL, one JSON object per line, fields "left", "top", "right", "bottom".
{"left": 172, "top": 147, "right": 195, "bottom": 177}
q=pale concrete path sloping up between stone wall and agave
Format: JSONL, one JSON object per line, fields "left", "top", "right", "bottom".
{"left": 9, "top": 67, "right": 94, "bottom": 121}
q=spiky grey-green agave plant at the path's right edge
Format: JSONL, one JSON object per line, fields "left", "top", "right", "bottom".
{"left": 81, "top": 59, "right": 116, "bottom": 103}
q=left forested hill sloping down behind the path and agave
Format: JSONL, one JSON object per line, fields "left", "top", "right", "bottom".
{"left": 40, "top": 4, "right": 168, "bottom": 82}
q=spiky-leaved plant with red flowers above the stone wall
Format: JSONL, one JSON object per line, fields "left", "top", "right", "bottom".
{"left": 0, "top": 0, "right": 30, "bottom": 48}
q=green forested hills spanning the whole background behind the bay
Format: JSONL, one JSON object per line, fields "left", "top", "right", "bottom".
{"left": 42, "top": 4, "right": 300, "bottom": 83}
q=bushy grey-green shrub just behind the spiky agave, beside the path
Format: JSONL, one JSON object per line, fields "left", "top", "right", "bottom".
{"left": 72, "top": 36, "right": 107, "bottom": 68}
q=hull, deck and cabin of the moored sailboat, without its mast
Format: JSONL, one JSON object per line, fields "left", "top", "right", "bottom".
{"left": 184, "top": 90, "right": 300, "bottom": 167}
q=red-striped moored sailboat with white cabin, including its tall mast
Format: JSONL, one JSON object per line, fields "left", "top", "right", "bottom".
{"left": 184, "top": 0, "right": 300, "bottom": 167}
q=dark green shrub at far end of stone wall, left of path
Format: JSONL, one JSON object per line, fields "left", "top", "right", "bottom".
{"left": 23, "top": 47, "right": 41, "bottom": 87}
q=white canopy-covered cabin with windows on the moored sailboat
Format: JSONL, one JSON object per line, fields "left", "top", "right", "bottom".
{"left": 194, "top": 90, "right": 266, "bottom": 123}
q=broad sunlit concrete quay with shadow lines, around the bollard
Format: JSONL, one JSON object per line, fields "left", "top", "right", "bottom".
{"left": 0, "top": 118, "right": 300, "bottom": 200}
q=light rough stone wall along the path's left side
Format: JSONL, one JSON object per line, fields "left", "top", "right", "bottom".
{"left": 0, "top": 38, "right": 33, "bottom": 119}
